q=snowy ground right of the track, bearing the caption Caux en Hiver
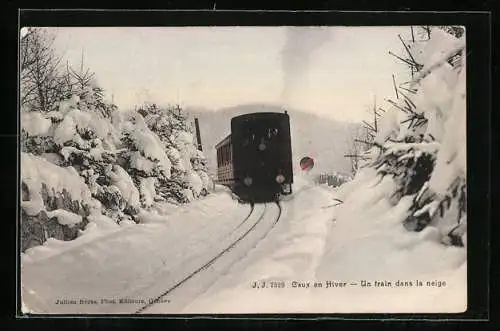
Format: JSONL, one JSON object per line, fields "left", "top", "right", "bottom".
{"left": 183, "top": 170, "right": 467, "bottom": 313}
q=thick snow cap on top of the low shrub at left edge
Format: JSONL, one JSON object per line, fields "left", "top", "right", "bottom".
{"left": 20, "top": 153, "right": 91, "bottom": 215}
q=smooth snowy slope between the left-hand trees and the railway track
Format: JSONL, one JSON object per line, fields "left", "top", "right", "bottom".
{"left": 21, "top": 185, "right": 249, "bottom": 313}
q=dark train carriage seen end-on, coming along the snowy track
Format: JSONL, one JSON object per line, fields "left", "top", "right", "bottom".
{"left": 215, "top": 111, "right": 293, "bottom": 203}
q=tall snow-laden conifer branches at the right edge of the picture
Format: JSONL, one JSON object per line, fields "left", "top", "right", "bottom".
{"left": 346, "top": 28, "right": 467, "bottom": 246}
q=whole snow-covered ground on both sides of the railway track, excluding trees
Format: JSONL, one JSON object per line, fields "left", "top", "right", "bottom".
{"left": 22, "top": 169, "right": 467, "bottom": 314}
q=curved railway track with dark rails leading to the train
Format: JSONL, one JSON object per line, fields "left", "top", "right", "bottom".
{"left": 135, "top": 202, "right": 282, "bottom": 314}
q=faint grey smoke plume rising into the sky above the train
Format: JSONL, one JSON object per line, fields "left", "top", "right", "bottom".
{"left": 281, "top": 26, "right": 330, "bottom": 105}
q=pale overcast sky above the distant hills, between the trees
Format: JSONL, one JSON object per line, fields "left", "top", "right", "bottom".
{"left": 47, "top": 26, "right": 410, "bottom": 121}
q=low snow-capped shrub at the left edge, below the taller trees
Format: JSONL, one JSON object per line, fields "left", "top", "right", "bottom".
{"left": 20, "top": 153, "right": 97, "bottom": 251}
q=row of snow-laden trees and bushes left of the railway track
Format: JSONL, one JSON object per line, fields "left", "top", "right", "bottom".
{"left": 21, "top": 29, "right": 209, "bottom": 250}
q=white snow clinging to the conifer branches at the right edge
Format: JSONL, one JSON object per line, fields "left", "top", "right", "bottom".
{"left": 375, "top": 29, "right": 467, "bottom": 205}
